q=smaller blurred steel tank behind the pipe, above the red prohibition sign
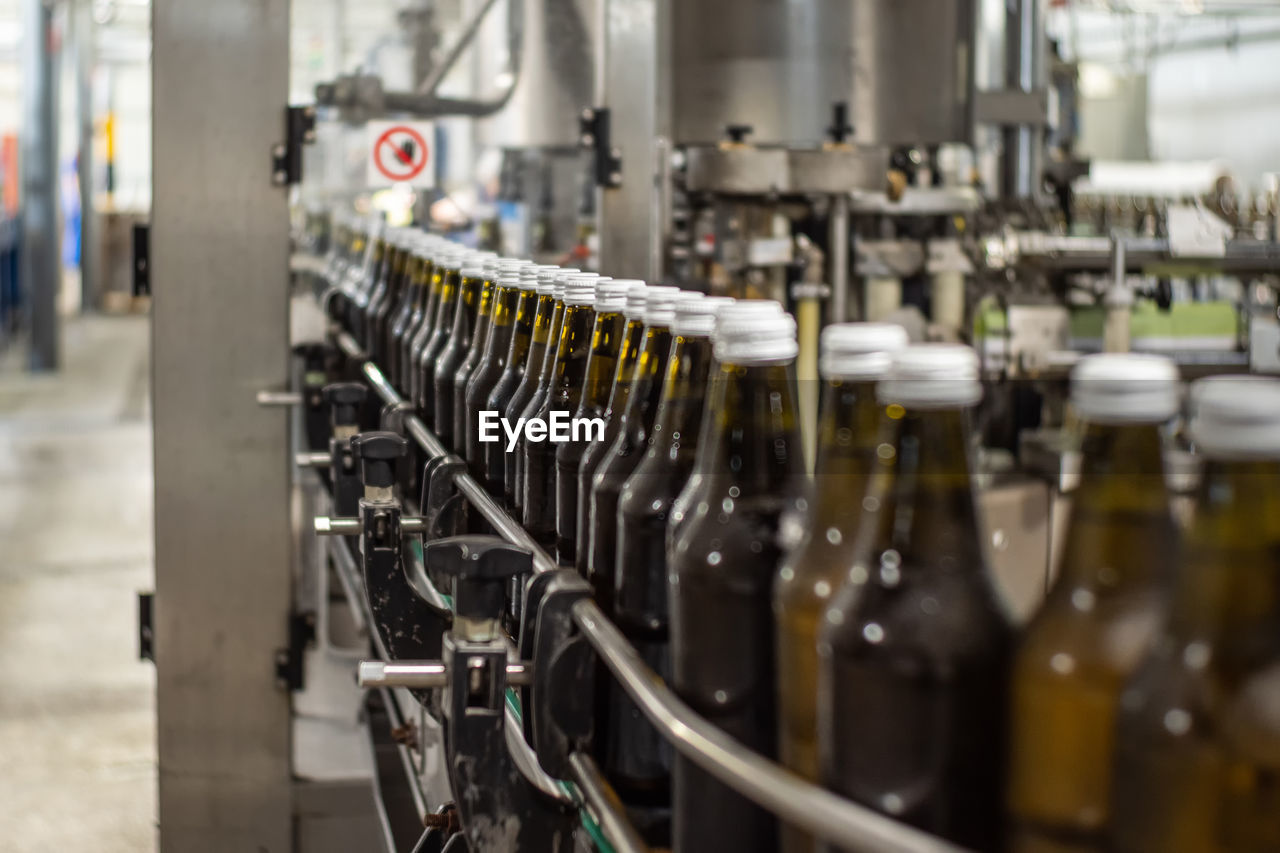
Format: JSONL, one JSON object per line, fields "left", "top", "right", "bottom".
{"left": 477, "top": 0, "right": 596, "bottom": 149}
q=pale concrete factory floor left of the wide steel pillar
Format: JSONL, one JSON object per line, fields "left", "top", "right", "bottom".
{"left": 0, "top": 316, "right": 156, "bottom": 853}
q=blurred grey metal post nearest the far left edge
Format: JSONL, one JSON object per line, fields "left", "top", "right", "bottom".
{"left": 22, "top": 0, "right": 61, "bottom": 370}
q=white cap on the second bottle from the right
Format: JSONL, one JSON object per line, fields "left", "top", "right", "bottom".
{"left": 1071, "top": 353, "right": 1179, "bottom": 424}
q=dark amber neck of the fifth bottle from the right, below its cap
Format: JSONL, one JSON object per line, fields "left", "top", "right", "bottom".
{"left": 698, "top": 361, "right": 804, "bottom": 498}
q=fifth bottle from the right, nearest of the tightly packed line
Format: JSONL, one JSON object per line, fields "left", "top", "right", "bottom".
{"left": 668, "top": 305, "right": 804, "bottom": 853}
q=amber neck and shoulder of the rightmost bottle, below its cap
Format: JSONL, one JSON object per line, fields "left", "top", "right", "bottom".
{"left": 1170, "top": 459, "right": 1280, "bottom": 676}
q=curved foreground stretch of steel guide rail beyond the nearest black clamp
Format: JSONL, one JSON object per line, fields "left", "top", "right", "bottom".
{"left": 572, "top": 598, "right": 961, "bottom": 853}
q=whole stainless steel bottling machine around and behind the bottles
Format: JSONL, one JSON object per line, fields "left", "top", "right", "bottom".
{"left": 146, "top": 0, "right": 1280, "bottom": 853}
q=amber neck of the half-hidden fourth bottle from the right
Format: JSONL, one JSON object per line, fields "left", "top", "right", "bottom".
{"left": 814, "top": 379, "right": 881, "bottom": 526}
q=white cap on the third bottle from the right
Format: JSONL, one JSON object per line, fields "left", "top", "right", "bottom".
{"left": 876, "top": 343, "right": 982, "bottom": 409}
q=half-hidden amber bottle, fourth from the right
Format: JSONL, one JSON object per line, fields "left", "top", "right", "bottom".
{"left": 773, "top": 323, "right": 906, "bottom": 853}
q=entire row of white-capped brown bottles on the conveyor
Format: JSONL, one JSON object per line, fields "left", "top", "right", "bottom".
{"left": 329, "top": 217, "right": 1280, "bottom": 853}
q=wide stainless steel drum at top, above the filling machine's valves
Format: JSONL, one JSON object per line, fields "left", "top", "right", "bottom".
{"left": 669, "top": 0, "right": 974, "bottom": 146}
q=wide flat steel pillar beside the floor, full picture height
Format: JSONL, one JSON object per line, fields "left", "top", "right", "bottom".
{"left": 151, "top": 0, "right": 293, "bottom": 853}
